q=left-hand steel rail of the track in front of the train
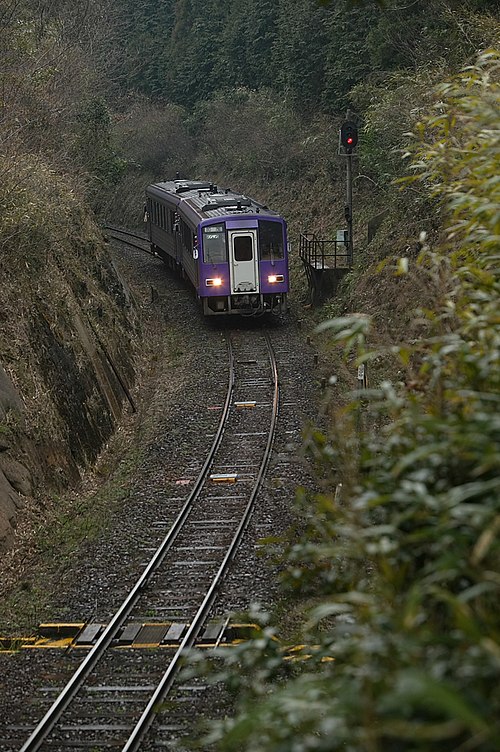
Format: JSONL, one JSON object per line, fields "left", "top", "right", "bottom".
{"left": 20, "top": 338, "right": 234, "bottom": 752}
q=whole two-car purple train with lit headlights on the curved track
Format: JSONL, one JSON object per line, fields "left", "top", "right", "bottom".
{"left": 145, "top": 180, "right": 288, "bottom": 316}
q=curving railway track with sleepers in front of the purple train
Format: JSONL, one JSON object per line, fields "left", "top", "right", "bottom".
{"left": 12, "top": 331, "right": 279, "bottom": 752}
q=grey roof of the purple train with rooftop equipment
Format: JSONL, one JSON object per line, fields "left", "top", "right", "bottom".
{"left": 146, "top": 180, "right": 279, "bottom": 221}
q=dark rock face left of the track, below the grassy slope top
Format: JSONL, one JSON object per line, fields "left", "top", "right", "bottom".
{"left": 0, "top": 244, "right": 139, "bottom": 552}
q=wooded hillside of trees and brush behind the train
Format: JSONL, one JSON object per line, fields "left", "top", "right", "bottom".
{"left": 0, "top": 0, "right": 498, "bottom": 221}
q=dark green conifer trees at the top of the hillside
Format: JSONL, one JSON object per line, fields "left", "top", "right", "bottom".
{"left": 109, "top": 0, "right": 496, "bottom": 119}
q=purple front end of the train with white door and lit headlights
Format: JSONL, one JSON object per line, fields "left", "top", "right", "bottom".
{"left": 197, "top": 214, "right": 289, "bottom": 316}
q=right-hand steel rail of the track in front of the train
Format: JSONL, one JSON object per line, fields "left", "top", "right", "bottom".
{"left": 122, "top": 333, "right": 279, "bottom": 752}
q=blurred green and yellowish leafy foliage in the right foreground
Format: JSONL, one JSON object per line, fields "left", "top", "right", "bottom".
{"left": 201, "top": 51, "right": 500, "bottom": 752}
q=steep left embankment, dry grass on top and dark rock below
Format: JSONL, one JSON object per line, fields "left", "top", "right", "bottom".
{"left": 0, "top": 159, "right": 138, "bottom": 550}
